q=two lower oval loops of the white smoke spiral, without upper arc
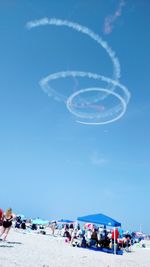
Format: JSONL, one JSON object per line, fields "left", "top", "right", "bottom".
{"left": 40, "top": 71, "right": 130, "bottom": 125}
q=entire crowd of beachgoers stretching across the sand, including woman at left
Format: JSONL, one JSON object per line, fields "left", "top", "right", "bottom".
{"left": 0, "top": 208, "right": 145, "bottom": 254}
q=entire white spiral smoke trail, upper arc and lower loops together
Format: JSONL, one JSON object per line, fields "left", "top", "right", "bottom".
{"left": 27, "top": 18, "right": 130, "bottom": 125}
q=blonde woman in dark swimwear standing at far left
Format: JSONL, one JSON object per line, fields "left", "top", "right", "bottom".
{"left": 0, "top": 208, "right": 14, "bottom": 241}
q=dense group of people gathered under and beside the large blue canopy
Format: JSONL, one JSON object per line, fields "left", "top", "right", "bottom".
{"left": 64, "top": 224, "right": 132, "bottom": 253}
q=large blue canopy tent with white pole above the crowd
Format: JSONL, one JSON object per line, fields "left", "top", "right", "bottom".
{"left": 77, "top": 213, "right": 121, "bottom": 254}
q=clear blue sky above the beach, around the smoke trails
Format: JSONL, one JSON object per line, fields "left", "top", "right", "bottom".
{"left": 0, "top": 0, "right": 150, "bottom": 232}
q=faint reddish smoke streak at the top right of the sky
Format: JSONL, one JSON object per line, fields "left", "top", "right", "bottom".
{"left": 104, "top": 0, "right": 125, "bottom": 34}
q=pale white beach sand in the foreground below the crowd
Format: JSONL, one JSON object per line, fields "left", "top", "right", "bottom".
{"left": 0, "top": 229, "right": 150, "bottom": 267}
